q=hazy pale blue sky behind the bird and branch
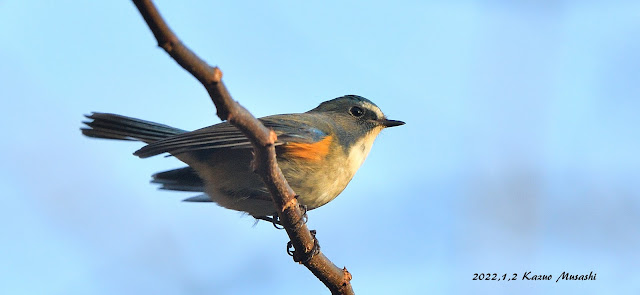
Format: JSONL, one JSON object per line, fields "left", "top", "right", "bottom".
{"left": 0, "top": 0, "right": 640, "bottom": 294}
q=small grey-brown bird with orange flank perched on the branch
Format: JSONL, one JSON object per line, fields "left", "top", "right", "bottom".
{"left": 81, "top": 95, "right": 404, "bottom": 220}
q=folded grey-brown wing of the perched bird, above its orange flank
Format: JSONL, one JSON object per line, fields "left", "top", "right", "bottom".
{"left": 134, "top": 114, "right": 327, "bottom": 158}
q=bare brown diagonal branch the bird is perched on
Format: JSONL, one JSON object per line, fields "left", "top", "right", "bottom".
{"left": 133, "top": 0, "right": 354, "bottom": 294}
